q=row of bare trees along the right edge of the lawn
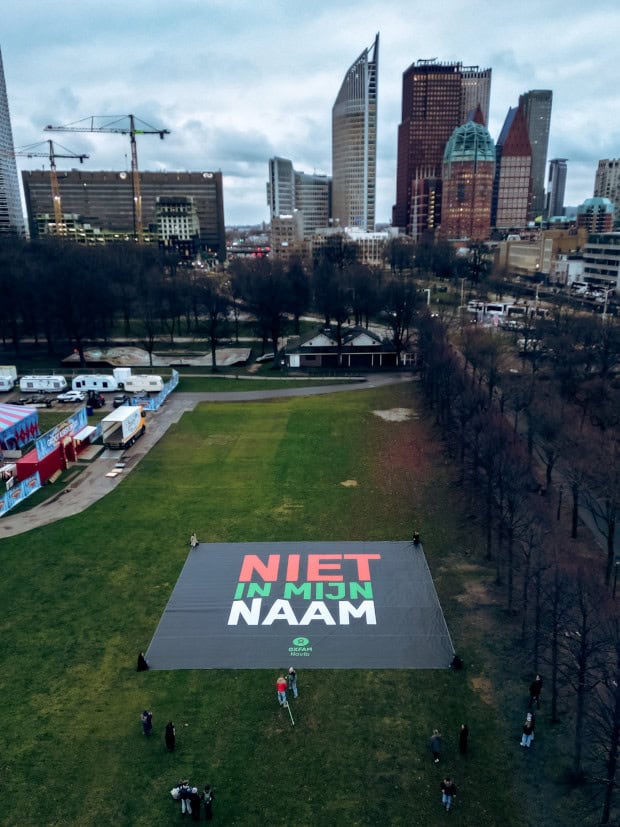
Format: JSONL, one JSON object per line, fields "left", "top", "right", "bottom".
{"left": 418, "top": 315, "right": 620, "bottom": 824}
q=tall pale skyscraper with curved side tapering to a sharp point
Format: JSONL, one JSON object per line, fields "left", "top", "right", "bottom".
{"left": 332, "top": 34, "right": 379, "bottom": 231}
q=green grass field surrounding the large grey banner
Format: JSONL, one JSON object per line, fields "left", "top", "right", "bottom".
{"left": 0, "top": 385, "right": 580, "bottom": 827}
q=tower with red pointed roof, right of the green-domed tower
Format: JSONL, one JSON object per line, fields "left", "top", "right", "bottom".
{"left": 491, "top": 106, "right": 532, "bottom": 230}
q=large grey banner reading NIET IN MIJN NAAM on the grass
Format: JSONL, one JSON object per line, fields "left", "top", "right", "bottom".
{"left": 147, "top": 541, "right": 454, "bottom": 669}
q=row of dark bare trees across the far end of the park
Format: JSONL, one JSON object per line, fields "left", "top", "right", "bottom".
{"left": 0, "top": 239, "right": 420, "bottom": 367}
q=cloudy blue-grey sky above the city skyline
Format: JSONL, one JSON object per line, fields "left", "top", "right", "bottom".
{"left": 0, "top": 0, "right": 620, "bottom": 225}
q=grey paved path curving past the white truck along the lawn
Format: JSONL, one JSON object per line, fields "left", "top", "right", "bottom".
{"left": 0, "top": 373, "right": 412, "bottom": 539}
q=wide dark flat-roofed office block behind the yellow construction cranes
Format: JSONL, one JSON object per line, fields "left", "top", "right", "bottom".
{"left": 22, "top": 170, "right": 226, "bottom": 261}
